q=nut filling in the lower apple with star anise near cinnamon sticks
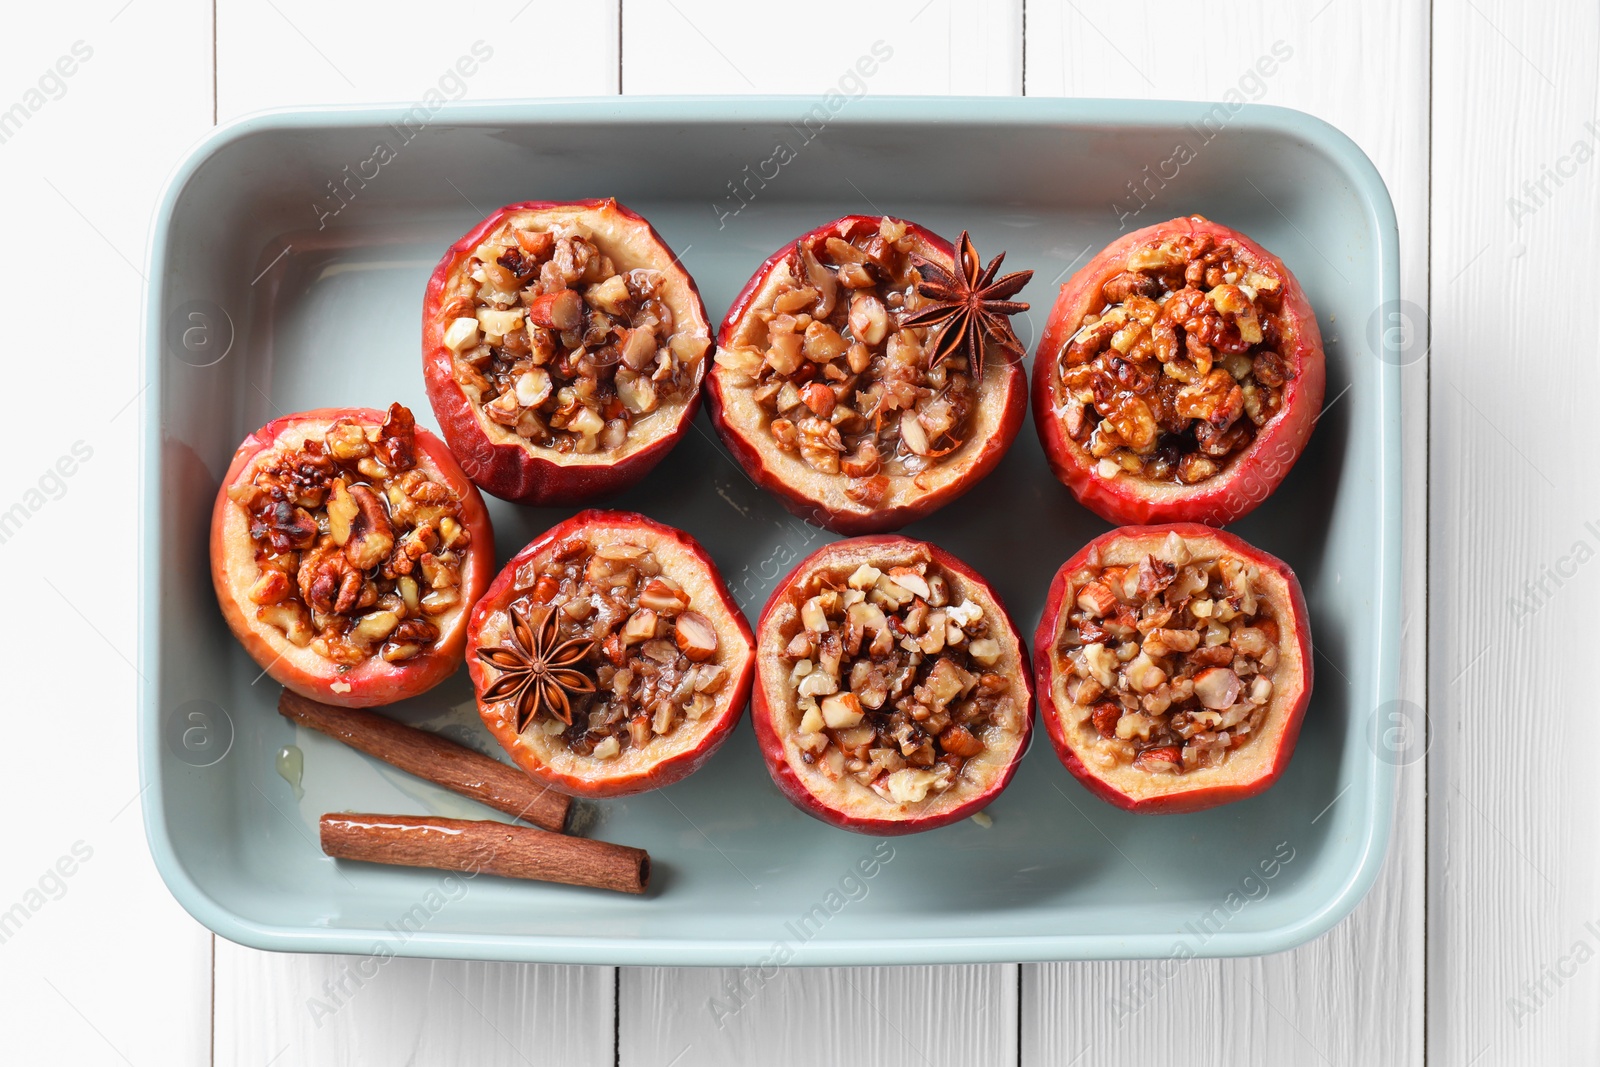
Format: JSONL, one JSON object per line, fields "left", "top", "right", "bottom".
{"left": 480, "top": 537, "right": 728, "bottom": 760}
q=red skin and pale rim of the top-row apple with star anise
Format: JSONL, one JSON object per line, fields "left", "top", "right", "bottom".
{"left": 706, "top": 214, "right": 1027, "bottom": 536}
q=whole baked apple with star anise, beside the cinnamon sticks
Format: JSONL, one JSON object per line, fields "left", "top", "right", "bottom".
{"left": 467, "top": 510, "right": 755, "bottom": 797}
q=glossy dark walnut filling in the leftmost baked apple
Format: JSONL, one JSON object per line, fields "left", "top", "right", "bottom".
{"left": 227, "top": 403, "right": 470, "bottom": 669}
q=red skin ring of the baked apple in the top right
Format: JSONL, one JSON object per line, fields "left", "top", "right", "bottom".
{"left": 1034, "top": 216, "right": 1328, "bottom": 526}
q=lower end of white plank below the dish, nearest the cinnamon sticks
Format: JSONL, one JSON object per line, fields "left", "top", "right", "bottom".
{"left": 216, "top": 937, "right": 616, "bottom": 1067}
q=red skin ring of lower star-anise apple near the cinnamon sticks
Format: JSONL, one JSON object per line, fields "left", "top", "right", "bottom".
{"left": 467, "top": 509, "right": 755, "bottom": 798}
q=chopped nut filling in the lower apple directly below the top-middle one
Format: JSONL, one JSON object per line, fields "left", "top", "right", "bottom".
{"left": 782, "top": 561, "right": 1022, "bottom": 803}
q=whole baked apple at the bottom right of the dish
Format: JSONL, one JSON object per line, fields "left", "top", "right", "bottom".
{"left": 1034, "top": 523, "right": 1312, "bottom": 813}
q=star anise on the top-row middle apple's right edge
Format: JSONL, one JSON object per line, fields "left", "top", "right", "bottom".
{"left": 901, "top": 230, "right": 1034, "bottom": 381}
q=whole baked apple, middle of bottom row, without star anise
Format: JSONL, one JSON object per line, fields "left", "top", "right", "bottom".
{"left": 750, "top": 534, "right": 1034, "bottom": 835}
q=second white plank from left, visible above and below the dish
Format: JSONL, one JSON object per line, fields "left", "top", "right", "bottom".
{"left": 206, "top": 8, "right": 618, "bottom": 1065}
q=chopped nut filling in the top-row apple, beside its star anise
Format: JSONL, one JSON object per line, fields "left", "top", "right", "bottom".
{"left": 717, "top": 218, "right": 976, "bottom": 507}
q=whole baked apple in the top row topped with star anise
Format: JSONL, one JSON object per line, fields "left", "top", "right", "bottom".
{"left": 706, "top": 214, "right": 1032, "bottom": 534}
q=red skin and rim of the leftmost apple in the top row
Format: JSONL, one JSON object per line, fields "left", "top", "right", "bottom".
{"left": 422, "top": 198, "right": 715, "bottom": 507}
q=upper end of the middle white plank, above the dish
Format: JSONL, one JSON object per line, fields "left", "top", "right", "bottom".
{"left": 622, "top": 0, "right": 1022, "bottom": 96}
